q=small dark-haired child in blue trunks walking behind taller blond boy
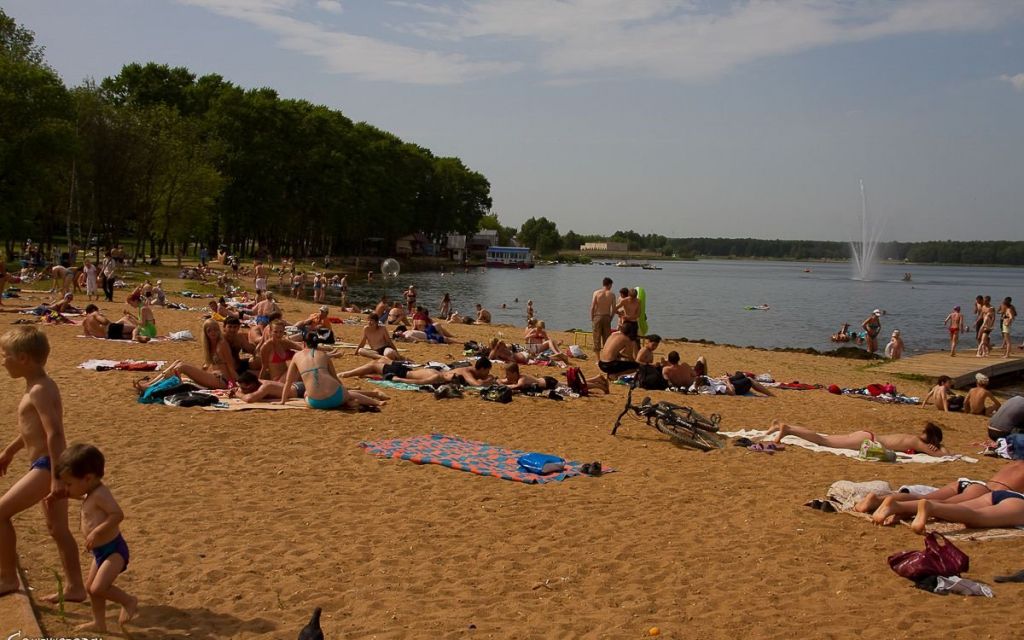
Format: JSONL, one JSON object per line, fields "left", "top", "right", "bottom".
{"left": 56, "top": 444, "right": 138, "bottom": 632}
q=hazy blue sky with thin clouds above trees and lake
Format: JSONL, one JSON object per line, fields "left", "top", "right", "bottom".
{"left": 3, "top": 0, "right": 1024, "bottom": 241}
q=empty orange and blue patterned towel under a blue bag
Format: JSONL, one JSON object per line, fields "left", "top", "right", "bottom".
{"left": 359, "top": 433, "right": 612, "bottom": 484}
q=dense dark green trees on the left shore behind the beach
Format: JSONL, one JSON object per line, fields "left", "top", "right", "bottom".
{"left": 0, "top": 9, "right": 492, "bottom": 256}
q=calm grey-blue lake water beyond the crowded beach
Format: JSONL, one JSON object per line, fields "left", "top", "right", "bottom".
{"left": 276, "top": 260, "right": 1024, "bottom": 352}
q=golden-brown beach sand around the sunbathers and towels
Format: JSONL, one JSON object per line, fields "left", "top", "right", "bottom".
{"left": 0, "top": 279, "right": 1024, "bottom": 640}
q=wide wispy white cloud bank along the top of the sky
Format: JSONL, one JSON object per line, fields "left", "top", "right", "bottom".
{"left": 178, "top": 0, "right": 1024, "bottom": 86}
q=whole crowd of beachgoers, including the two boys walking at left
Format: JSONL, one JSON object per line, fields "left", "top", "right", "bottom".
{"left": 0, "top": 252, "right": 1024, "bottom": 632}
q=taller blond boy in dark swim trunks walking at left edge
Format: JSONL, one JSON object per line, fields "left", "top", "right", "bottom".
{"left": 0, "top": 327, "right": 86, "bottom": 602}
